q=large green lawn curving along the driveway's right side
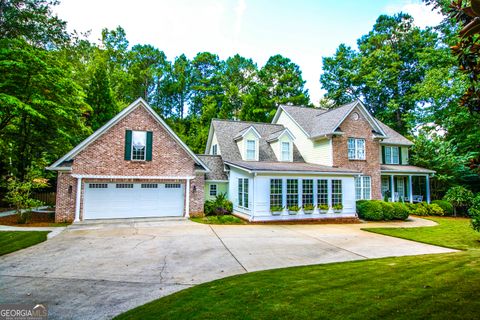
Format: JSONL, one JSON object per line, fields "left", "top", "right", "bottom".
{"left": 117, "top": 218, "right": 480, "bottom": 319}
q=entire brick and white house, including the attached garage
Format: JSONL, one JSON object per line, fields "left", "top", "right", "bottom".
{"left": 48, "top": 99, "right": 433, "bottom": 221}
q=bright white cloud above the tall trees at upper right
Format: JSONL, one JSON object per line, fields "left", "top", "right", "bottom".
{"left": 385, "top": 0, "right": 444, "bottom": 28}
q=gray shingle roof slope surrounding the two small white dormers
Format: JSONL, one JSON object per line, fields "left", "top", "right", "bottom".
{"left": 212, "top": 119, "right": 304, "bottom": 162}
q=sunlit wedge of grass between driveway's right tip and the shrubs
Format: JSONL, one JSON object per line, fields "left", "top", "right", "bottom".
{"left": 362, "top": 217, "right": 480, "bottom": 250}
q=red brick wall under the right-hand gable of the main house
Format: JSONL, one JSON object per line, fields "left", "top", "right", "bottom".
{"left": 332, "top": 108, "right": 382, "bottom": 199}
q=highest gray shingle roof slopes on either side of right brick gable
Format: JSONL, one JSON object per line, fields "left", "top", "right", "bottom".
{"left": 282, "top": 101, "right": 413, "bottom": 146}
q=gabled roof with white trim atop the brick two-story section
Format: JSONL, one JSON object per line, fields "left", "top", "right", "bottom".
{"left": 272, "top": 101, "right": 386, "bottom": 139}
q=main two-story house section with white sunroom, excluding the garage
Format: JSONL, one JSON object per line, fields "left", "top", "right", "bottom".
{"left": 202, "top": 101, "right": 434, "bottom": 221}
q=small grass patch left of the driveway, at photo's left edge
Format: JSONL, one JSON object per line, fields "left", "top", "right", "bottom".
{"left": 0, "top": 231, "right": 49, "bottom": 256}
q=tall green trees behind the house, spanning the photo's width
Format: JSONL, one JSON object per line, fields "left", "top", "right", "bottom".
{"left": 0, "top": 0, "right": 480, "bottom": 196}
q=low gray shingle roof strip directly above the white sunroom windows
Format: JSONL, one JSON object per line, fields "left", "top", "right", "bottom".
{"left": 225, "top": 161, "right": 360, "bottom": 174}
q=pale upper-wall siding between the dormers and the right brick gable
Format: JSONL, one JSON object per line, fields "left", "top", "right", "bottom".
{"left": 277, "top": 111, "right": 333, "bottom": 166}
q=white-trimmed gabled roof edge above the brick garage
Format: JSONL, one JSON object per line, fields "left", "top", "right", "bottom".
{"left": 46, "top": 98, "right": 208, "bottom": 172}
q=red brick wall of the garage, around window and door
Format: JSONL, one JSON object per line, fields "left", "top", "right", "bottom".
{"left": 55, "top": 107, "right": 205, "bottom": 221}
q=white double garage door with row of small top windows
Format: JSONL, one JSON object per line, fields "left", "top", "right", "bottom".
{"left": 83, "top": 182, "right": 184, "bottom": 219}
